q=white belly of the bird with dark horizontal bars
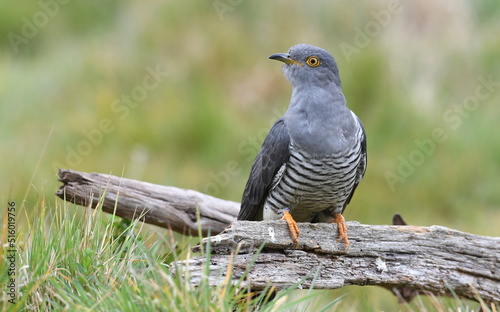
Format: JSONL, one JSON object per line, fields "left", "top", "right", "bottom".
{"left": 263, "top": 144, "right": 361, "bottom": 222}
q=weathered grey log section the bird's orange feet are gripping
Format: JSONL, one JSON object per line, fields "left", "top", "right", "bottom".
{"left": 177, "top": 220, "right": 500, "bottom": 302}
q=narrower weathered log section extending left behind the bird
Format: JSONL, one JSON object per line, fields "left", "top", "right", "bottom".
{"left": 56, "top": 169, "right": 240, "bottom": 235}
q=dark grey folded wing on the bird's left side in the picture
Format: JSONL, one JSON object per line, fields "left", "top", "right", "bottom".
{"left": 238, "top": 118, "right": 290, "bottom": 220}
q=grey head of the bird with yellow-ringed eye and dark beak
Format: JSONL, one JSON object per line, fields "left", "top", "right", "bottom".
{"left": 269, "top": 44, "right": 341, "bottom": 87}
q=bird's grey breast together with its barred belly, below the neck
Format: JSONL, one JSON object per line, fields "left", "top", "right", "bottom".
{"left": 264, "top": 97, "right": 362, "bottom": 221}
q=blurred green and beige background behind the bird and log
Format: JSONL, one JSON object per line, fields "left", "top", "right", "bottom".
{"left": 0, "top": 0, "right": 500, "bottom": 308}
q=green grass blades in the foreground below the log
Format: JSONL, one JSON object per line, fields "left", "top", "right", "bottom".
{"left": 0, "top": 198, "right": 494, "bottom": 311}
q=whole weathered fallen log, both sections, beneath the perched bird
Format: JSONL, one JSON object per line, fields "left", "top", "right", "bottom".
{"left": 56, "top": 170, "right": 500, "bottom": 303}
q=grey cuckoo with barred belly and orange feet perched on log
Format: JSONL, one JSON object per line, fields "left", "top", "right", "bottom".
{"left": 237, "top": 44, "right": 367, "bottom": 250}
